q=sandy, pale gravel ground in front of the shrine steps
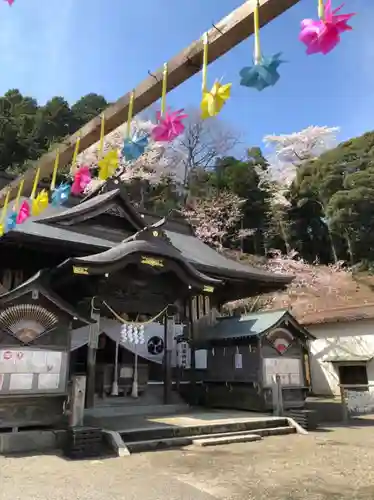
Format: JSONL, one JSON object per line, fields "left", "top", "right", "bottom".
{"left": 0, "top": 422, "right": 374, "bottom": 500}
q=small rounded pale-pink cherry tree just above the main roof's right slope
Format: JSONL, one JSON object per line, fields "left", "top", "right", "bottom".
{"left": 182, "top": 191, "right": 245, "bottom": 249}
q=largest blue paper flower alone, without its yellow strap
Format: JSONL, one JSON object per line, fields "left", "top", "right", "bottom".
{"left": 239, "top": 52, "right": 284, "bottom": 90}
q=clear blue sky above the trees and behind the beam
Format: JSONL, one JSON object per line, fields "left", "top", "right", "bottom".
{"left": 0, "top": 0, "right": 374, "bottom": 152}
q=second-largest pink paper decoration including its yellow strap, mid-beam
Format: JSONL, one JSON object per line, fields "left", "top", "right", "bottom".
{"left": 152, "top": 63, "right": 187, "bottom": 142}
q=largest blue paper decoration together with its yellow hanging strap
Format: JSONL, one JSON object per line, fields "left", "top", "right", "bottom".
{"left": 239, "top": 0, "right": 284, "bottom": 91}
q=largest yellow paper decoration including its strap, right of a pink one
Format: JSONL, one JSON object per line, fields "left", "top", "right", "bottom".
{"left": 200, "top": 33, "right": 232, "bottom": 120}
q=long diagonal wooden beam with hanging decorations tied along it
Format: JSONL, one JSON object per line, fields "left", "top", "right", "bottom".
{"left": 0, "top": 0, "right": 299, "bottom": 206}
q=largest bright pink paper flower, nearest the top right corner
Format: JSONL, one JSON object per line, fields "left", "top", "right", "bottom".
{"left": 299, "top": 0, "right": 355, "bottom": 55}
